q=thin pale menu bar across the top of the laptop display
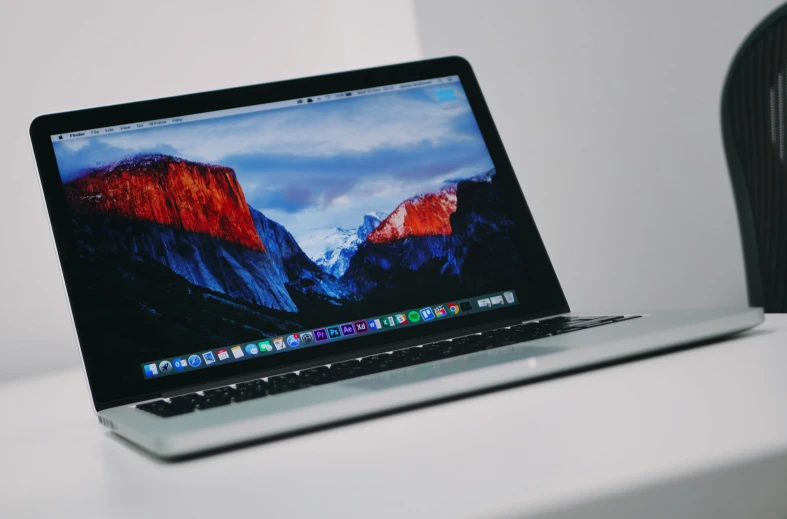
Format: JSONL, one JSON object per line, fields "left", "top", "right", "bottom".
{"left": 51, "top": 76, "right": 459, "bottom": 142}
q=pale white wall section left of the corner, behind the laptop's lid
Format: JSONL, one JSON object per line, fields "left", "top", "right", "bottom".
{"left": 0, "top": 0, "right": 421, "bottom": 382}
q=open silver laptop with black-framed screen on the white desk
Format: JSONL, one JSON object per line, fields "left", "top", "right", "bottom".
{"left": 30, "top": 57, "right": 763, "bottom": 458}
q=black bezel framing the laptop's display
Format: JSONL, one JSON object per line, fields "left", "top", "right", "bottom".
{"left": 30, "top": 57, "right": 570, "bottom": 411}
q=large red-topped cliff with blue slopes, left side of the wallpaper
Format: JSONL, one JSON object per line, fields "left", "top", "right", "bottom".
{"left": 64, "top": 155, "right": 346, "bottom": 312}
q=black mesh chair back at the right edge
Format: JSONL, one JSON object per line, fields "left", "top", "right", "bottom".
{"left": 721, "top": 4, "right": 787, "bottom": 312}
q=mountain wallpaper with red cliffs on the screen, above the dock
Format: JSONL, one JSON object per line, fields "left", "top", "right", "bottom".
{"left": 55, "top": 84, "right": 523, "bottom": 360}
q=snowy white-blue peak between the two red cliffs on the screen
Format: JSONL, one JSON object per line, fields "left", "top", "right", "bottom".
{"left": 298, "top": 212, "right": 386, "bottom": 278}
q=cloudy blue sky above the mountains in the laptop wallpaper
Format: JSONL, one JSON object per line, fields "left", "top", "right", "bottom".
{"left": 55, "top": 83, "right": 493, "bottom": 238}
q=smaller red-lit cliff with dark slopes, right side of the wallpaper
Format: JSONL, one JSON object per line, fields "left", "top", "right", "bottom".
{"left": 342, "top": 170, "right": 521, "bottom": 299}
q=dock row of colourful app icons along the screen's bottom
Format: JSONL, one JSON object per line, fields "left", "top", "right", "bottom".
{"left": 142, "top": 290, "right": 519, "bottom": 380}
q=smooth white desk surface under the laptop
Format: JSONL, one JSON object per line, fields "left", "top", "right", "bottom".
{"left": 0, "top": 315, "right": 787, "bottom": 519}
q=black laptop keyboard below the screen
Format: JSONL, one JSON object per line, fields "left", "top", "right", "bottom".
{"left": 136, "top": 315, "right": 640, "bottom": 418}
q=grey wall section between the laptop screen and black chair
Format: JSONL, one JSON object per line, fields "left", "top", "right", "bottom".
{"left": 416, "top": 0, "right": 781, "bottom": 310}
